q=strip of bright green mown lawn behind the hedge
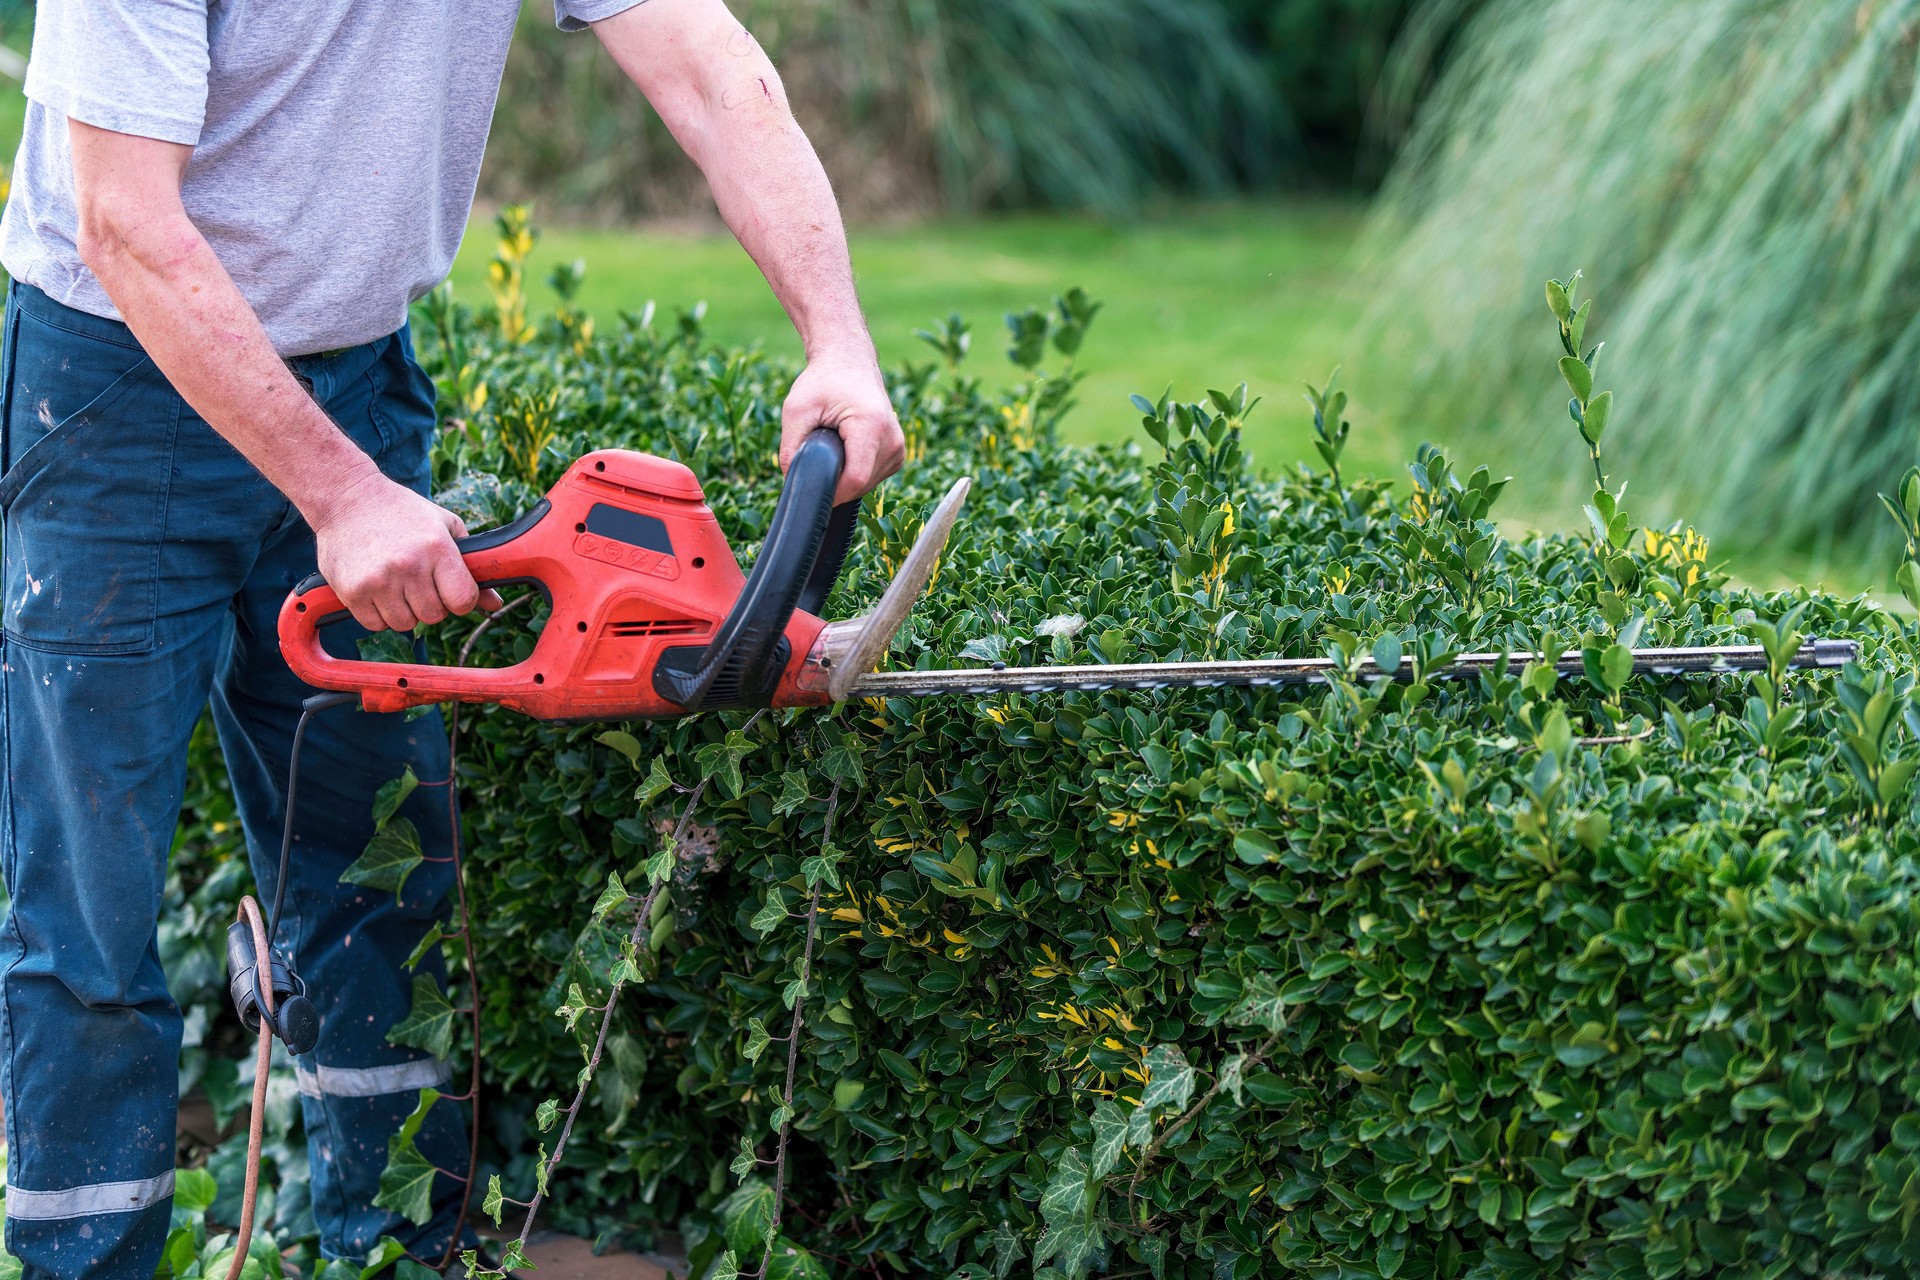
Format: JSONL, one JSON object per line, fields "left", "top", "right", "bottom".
{"left": 453, "top": 203, "right": 1402, "bottom": 470}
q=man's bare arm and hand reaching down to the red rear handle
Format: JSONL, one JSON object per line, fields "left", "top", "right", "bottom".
{"left": 67, "top": 121, "right": 482, "bottom": 629}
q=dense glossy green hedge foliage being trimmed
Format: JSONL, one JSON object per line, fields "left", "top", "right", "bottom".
{"left": 168, "top": 260, "right": 1920, "bottom": 1280}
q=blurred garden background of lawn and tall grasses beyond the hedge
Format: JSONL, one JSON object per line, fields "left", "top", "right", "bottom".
{"left": 0, "top": 0, "right": 1920, "bottom": 587}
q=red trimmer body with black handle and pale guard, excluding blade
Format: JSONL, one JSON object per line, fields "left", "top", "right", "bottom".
{"left": 280, "top": 430, "right": 968, "bottom": 722}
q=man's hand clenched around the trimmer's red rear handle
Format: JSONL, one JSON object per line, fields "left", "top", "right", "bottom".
{"left": 313, "top": 468, "right": 501, "bottom": 631}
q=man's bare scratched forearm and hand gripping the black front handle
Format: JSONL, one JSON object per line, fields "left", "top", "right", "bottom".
{"left": 593, "top": 0, "right": 904, "bottom": 501}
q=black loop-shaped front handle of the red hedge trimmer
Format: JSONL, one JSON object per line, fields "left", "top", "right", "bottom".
{"left": 653, "top": 426, "right": 860, "bottom": 712}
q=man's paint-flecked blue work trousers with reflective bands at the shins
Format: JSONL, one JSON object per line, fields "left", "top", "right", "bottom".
{"left": 0, "top": 284, "right": 467, "bottom": 1280}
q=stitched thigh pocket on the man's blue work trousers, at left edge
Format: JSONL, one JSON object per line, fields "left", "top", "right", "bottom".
{"left": 0, "top": 290, "right": 180, "bottom": 654}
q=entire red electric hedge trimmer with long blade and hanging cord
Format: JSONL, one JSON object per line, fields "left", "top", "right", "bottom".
{"left": 217, "top": 430, "right": 1857, "bottom": 1276}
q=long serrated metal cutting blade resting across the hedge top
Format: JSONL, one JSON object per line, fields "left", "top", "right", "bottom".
{"left": 849, "top": 639, "right": 1860, "bottom": 699}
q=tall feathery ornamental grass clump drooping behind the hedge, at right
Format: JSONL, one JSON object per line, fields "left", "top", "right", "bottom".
{"left": 1375, "top": 0, "right": 1920, "bottom": 553}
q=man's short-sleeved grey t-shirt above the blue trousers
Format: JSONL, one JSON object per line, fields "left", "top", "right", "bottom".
{"left": 0, "top": 0, "right": 641, "bottom": 355}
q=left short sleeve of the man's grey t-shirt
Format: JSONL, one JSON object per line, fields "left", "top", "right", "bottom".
{"left": 25, "top": 0, "right": 207, "bottom": 146}
